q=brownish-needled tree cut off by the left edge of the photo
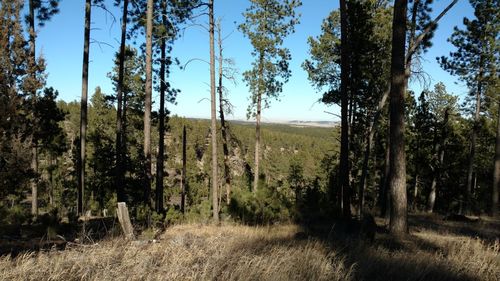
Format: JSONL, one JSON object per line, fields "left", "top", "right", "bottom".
{"left": 0, "top": 0, "right": 34, "bottom": 198}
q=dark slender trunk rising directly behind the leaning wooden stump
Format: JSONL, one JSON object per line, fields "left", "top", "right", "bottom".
{"left": 116, "top": 0, "right": 128, "bottom": 202}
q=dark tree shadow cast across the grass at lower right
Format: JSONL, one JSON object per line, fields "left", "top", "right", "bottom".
{"left": 298, "top": 219, "right": 478, "bottom": 281}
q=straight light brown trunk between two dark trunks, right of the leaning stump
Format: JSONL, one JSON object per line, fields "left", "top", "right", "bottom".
{"left": 144, "top": 0, "right": 153, "bottom": 206}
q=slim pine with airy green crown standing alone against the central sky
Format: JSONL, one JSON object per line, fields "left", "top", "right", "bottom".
{"left": 239, "top": 0, "right": 302, "bottom": 192}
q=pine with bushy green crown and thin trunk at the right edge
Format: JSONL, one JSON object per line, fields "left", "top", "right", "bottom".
{"left": 438, "top": 0, "right": 500, "bottom": 213}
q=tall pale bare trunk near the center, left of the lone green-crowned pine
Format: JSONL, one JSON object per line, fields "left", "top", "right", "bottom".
{"left": 208, "top": 0, "right": 219, "bottom": 223}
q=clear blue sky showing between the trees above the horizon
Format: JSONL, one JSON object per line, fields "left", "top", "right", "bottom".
{"left": 37, "top": 0, "right": 473, "bottom": 121}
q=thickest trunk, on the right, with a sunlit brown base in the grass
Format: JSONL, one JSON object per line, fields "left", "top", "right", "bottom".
{"left": 389, "top": 0, "right": 408, "bottom": 236}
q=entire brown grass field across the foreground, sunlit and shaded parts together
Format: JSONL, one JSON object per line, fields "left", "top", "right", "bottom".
{"left": 0, "top": 215, "right": 500, "bottom": 281}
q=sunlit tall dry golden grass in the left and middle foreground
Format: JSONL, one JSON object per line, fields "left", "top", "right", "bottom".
{"left": 0, "top": 224, "right": 352, "bottom": 280}
